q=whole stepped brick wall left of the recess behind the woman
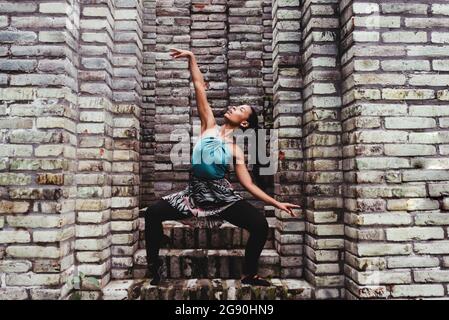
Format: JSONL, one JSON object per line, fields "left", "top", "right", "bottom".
{"left": 0, "top": 0, "right": 143, "bottom": 299}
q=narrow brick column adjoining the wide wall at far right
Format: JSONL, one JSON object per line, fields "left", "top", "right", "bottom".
{"left": 301, "top": 0, "right": 344, "bottom": 299}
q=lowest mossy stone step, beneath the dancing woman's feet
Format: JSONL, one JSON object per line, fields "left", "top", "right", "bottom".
{"left": 102, "top": 278, "right": 314, "bottom": 300}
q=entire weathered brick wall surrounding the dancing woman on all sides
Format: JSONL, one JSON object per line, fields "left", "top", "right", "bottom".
{"left": 0, "top": 0, "right": 449, "bottom": 299}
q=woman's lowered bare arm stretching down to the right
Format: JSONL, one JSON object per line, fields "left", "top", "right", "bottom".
{"left": 232, "top": 144, "right": 300, "bottom": 216}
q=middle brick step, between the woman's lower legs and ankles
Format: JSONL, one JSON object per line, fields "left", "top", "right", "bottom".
{"left": 133, "top": 249, "right": 280, "bottom": 279}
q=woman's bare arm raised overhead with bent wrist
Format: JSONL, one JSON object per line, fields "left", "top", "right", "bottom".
{"left": 170, "top": 48, "right": 216, "bottom": 133}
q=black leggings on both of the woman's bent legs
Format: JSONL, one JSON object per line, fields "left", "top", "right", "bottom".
{"left": 145, "top": 199, "right": 268, "bottom": 275}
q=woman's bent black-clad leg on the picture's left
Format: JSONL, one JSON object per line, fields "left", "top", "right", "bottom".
{"left": 145, "top": 199, "right": 186, "bottom": 267}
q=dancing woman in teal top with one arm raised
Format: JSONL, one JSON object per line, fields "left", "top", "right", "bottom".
{"left": 145, "top": 48, "right": 299, "bottom": 286}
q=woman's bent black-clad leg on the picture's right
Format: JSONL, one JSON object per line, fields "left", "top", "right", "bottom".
{"left": 219, "top": 200, "right": 269, "bottom": 276}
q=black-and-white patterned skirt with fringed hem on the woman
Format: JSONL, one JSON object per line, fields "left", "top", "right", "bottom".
{"left": 162, "top": 175, "right": 243, "bottom": 228}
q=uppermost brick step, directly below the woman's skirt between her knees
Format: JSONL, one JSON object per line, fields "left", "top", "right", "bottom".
{"left": 139, "top": 217, "right": 276, "bottom": 249}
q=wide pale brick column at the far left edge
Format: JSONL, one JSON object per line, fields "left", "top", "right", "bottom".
{"left": 0, "top": 1, "right": 79, "bottom": 299}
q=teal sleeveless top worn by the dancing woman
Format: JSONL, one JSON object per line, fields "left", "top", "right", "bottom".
{"left": 192, "top": 126, "right": 232, "bottom": 179}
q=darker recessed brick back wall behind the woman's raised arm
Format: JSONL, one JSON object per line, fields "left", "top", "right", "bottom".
{"left": 149, "top": 0, "right": 272, "bottom": 208}
